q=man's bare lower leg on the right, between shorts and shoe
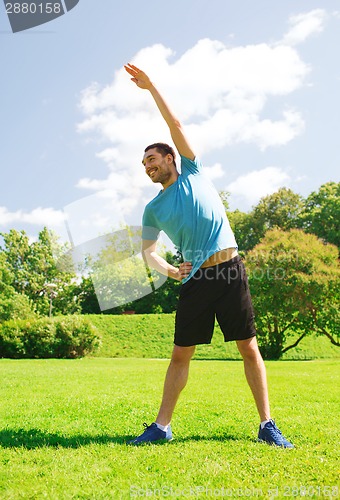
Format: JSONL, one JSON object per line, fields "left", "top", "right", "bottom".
{"left": 236, "top": 337, "right": 270, "bottom": 422}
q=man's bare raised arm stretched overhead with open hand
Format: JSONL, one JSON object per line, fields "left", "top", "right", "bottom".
{"left": 124, "top": 64, "right": 195, "bottom": 160}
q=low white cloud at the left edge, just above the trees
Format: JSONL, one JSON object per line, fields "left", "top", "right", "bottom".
{"left": 0, "top": 207, "right": 65, "bottom": 227}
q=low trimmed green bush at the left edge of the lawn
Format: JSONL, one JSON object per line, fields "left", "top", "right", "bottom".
{"left": 0, "top": 316, "right": 99, "bottom": 359}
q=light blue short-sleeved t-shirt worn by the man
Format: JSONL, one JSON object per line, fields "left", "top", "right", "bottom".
{"left": 142, "top": 156, "right": 237, "bottom": 283}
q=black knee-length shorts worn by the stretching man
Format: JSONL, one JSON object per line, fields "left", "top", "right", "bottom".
{"left": 174, "top": 256, "right": 256, "bottom": 347}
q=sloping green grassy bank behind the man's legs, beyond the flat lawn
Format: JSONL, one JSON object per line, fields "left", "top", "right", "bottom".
{"left": 89, "top": 314, "right": 340, "bottom": 360}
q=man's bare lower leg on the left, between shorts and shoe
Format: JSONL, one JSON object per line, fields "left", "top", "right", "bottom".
{"left": 156, "top": 345, "right": 195, "bottom": 425}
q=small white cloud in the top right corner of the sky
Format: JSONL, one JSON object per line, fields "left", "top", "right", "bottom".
{"left": 281, "top": 9, "right": 327, "bottom": 46}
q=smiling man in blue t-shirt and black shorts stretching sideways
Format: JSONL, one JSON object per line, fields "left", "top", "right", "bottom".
{"left": 125, "top": 60, "right": 293, "bottom": 448}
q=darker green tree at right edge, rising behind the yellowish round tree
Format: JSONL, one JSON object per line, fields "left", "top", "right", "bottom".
{"left": 300, "top": 182, "right": 340, "bottom": 247}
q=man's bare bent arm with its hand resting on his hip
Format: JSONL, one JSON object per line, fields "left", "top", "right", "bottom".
{"left": 142, "top": 240, "right": 192, "bottom": 281}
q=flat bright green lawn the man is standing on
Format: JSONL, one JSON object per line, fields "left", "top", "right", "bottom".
{"left": 0, "top": 358, "right": 340, "bottom": 500}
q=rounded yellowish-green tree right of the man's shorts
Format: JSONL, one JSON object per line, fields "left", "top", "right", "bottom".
{"left": 246, "top": 229, "right": 340, "bottom": 359}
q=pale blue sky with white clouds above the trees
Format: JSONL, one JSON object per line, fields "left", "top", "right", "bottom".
{"left": 0, "top": 0, "right": 340, "bottom": 242}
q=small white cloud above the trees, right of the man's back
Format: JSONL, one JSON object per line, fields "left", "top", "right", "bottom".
{"left": 226, "top": 167, "right": 290, "bottom": 208}
